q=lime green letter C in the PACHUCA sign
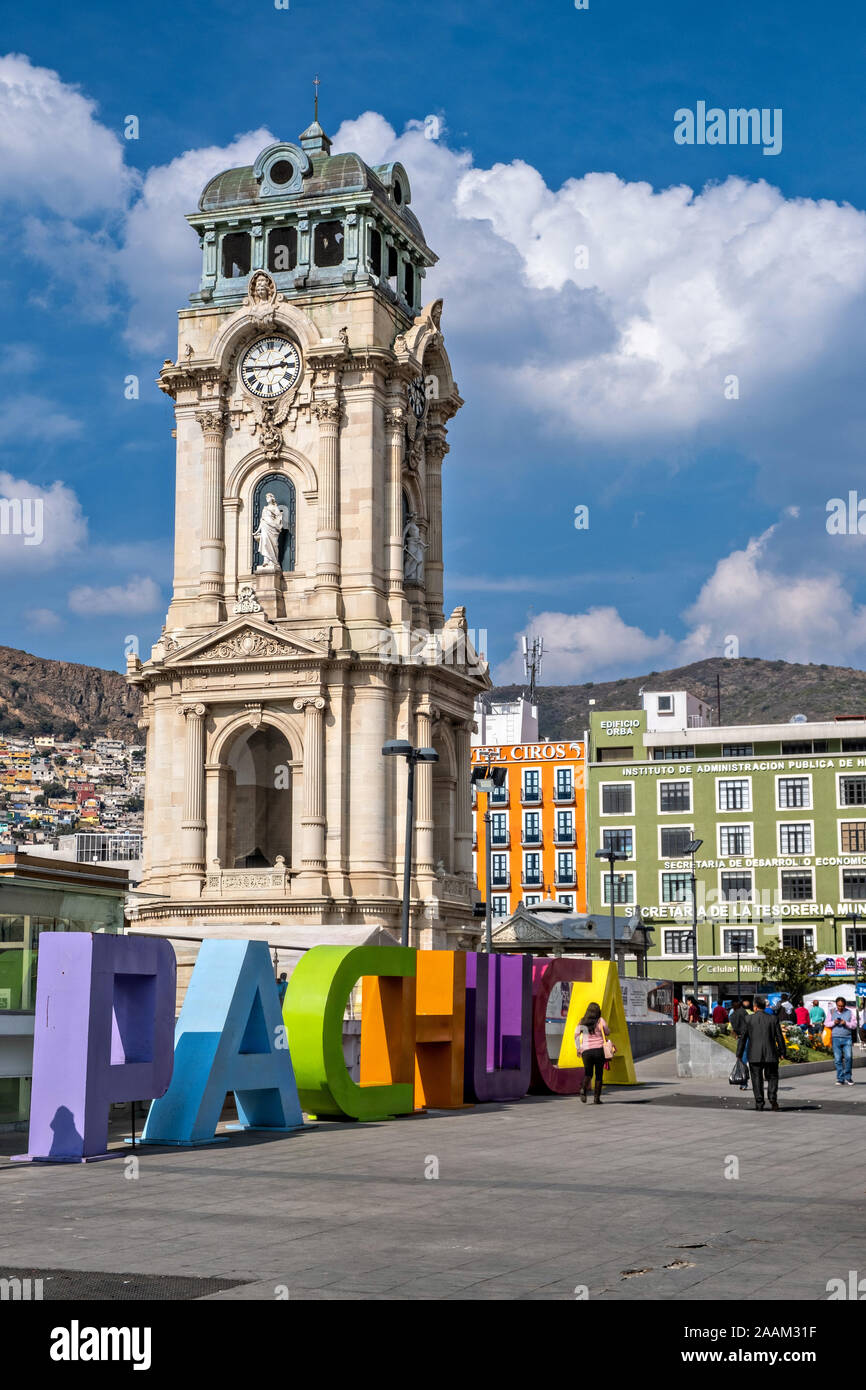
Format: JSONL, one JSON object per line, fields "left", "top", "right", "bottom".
{"left": 282, "top": 947, "right": 416, "bottom": 1120}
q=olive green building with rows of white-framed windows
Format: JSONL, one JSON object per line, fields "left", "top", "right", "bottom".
{"left": 587, "top": 691, "right": 866, "bottom": 1002}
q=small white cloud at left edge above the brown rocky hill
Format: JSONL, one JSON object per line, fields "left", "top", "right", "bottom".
{"left": 0, "top": 471, "right": 88, "bottom": 571}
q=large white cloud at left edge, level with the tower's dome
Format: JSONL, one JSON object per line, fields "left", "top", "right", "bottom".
{"left": 0, "top": 53, "right": 135, "bottom": 217}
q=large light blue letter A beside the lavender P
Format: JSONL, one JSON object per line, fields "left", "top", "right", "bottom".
{"left": 142, "top": 940, "right": 303, "bottom": 1144}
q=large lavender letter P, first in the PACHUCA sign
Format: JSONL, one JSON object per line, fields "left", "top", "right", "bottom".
{"left": 22, "top": 931, "right": 177, "bottom": 1163}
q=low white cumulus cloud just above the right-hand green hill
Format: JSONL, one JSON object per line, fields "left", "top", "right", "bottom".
{"left": 495, "top": 525, "right": 866, "bottom": 684}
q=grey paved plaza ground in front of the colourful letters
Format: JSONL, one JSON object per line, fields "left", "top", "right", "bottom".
{"left": 0, "top": 1054, "right": 866, "bottom": 1301}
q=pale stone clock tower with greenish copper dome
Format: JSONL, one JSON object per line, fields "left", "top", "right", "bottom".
{"left": 128, "top": 122, "right": 489, "bottom": 947}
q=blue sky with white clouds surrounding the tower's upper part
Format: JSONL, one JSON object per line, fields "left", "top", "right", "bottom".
{"left": 0, "top": 0, "right": 866, "bottom": 684}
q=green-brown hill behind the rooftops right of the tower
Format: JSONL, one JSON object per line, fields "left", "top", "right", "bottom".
{"left": 492, "top": 656, "right": 866, "bottom": 738}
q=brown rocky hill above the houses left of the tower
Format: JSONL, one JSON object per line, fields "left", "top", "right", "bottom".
{"left": 0, "top": 646, "right": 145, "bottom": 744}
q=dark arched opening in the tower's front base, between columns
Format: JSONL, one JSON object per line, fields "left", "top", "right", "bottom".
{"left": 224, "top": 724, "right": 292, "bottom": 869}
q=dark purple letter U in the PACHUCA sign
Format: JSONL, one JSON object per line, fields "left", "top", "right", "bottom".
{"left": 466, "top": 951, "right": 532, "bottom": 1102}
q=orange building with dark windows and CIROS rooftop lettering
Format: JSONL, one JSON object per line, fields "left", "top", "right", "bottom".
{"left": 471, "top": 742, "right": 587, "bottom": 919}
